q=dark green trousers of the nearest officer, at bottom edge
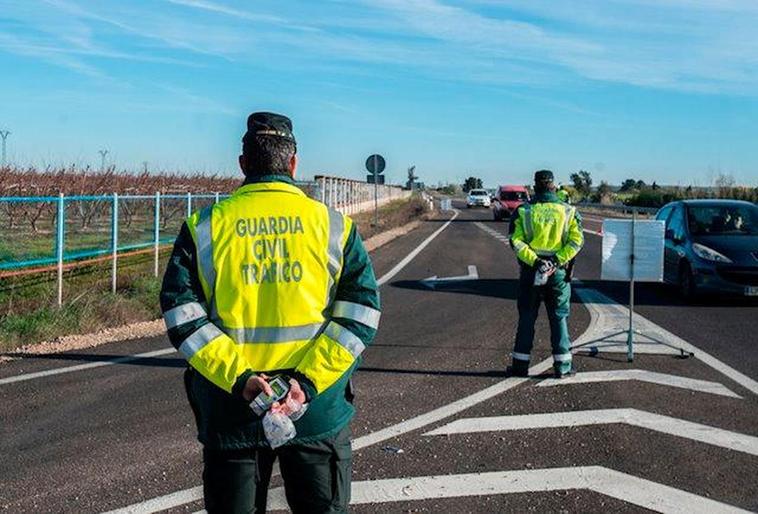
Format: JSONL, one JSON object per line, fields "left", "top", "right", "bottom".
{"left": 203, "top": 426, "right": 352, "bottom": 514}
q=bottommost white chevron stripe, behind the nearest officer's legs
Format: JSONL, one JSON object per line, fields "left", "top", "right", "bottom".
{"left": 269, "top": 466, "right": 748, "bottom": 514}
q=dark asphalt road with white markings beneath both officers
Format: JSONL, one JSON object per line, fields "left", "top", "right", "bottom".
{"left": 0, "top": 202, "right": 758, "bottom": 513}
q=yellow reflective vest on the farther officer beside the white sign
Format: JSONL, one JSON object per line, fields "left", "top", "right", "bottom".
{"left": 511, "top": 202, "right": 584, "bottom": 266}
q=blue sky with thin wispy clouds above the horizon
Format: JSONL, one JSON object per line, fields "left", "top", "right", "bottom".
{"left": 0, "top": 0, "right": 758, "bottom": 185}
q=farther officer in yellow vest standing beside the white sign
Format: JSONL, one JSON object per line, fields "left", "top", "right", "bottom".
{"left": 508, "top": 170, "right": 584, "bottom": 377}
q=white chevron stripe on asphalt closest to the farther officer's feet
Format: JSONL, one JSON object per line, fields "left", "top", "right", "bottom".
{"left": 537, "top": 369, "right": 742, "bottom": 398}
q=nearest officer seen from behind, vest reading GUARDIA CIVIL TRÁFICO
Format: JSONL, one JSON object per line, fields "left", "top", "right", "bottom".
{"left": 161, "top": 113, "right": 380, "bottom": 514}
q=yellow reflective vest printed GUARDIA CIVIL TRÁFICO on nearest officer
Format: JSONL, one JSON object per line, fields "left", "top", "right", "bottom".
{"left": 180, "top": 182, "right": 354, "bottom": 392}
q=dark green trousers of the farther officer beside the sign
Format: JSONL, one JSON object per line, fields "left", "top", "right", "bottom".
{"left": 512, "top": 266, "right": 571, "bottom": 373}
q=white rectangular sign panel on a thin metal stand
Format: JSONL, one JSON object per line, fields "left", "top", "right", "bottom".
{"left": 601, "top": 219, "right": 665, "bottom": 282}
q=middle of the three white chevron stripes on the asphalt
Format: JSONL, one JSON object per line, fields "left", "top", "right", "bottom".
{"left": 424, "top": 409, "right": 758, "bottom": 455}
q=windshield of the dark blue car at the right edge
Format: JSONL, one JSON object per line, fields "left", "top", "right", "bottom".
{"left": 687, "top": 205, "right": 758, "bottom": 236}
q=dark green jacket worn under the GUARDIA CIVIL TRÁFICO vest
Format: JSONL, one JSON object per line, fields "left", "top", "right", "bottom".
{"left": 160, "top": 175, "right": 380, "bottom": 449}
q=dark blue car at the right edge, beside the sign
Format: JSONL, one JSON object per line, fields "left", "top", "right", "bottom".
{"left": 656, "top": 200, "right": 758, "bottom": 299}
